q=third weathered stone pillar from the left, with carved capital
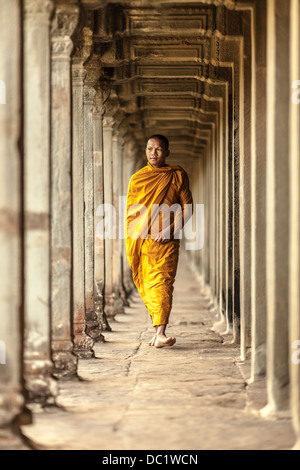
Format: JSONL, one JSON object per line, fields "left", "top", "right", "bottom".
{"left": 51, "top": 1, "right": 79, "bottom": 377}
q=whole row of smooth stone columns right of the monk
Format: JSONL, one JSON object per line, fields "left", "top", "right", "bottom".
{"left": 191, "top": 0, "right": 300, "bottom": 448}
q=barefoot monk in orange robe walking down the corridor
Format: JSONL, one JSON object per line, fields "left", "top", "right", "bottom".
{"left": 125, "top": 135, "right": 193, "bottom": 348}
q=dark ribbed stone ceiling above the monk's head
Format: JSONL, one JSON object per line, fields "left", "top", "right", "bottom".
{"left": 81, "top": 1, "right": 246, "bottom": 171}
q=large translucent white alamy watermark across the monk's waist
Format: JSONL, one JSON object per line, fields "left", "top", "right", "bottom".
{"left": 96, "top": 196, "right": 204, "bottom": 250}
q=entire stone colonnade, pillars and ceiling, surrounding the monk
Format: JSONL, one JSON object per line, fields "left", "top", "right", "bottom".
{"left": 0, "top": 0, "right": 300, "bottom": 447}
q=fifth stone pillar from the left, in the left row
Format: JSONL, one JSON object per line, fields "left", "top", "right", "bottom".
{"left": 93, "top": 87, "right": 110, "bottom": 340}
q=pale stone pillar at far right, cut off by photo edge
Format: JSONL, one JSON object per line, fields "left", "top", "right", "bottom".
{"left": 289, "top": 0, "right": 300, "bottom": 450}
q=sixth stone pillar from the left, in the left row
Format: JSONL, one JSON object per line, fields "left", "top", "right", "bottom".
{"left": 103, "top": 114, "right": 117, "bottom": 319}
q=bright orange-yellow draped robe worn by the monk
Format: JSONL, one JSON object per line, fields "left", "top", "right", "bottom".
{"left": 125, "top": 163, "right": 192, "bottom": 326}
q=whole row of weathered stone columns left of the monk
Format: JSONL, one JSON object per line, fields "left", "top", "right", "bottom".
{"left": 0, "top": 0, "right": 135, "bottom": 426}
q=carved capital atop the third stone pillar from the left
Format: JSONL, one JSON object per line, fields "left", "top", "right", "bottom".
{"left": 51, "top": 5, "right": 79, "bottom": 59}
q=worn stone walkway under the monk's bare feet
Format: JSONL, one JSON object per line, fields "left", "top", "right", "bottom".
{"left": 22, "top": 248, "right": 295, "bottom": 450}
